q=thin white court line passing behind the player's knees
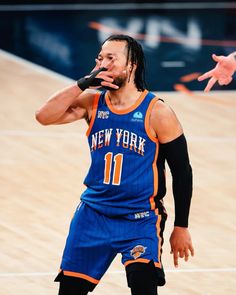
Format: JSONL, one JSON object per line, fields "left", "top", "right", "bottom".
{"left": 0, "top": 267, "right": 236, "bottom": 278}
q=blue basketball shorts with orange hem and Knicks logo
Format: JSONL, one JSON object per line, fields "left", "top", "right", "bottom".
{"left": 60, "top": 202, "right": 165, "bottom": 284}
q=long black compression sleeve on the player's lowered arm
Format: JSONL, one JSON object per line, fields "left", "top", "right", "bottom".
{"left": 161, "top": 134, "right": 192, "bottom": 227}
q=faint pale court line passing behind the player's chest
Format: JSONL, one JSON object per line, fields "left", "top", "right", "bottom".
{"left": 0, "top": 130, "right": 236, "bottom": 142}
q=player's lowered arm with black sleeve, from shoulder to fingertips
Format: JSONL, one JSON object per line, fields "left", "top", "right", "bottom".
{"left": 150, "top": 101, "right": 194, "bottom": 267}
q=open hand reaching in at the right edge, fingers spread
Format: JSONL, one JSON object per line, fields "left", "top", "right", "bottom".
{"left": 198, "top": 51, "right": 236, "bottom": 92}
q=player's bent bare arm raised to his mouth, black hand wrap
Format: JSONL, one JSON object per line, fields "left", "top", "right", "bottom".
{"left": 36, "top": 64, "right": 118, "bottom": 125}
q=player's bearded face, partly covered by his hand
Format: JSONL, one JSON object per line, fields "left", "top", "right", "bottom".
{"left": 97, "top": 41, "right": 128, "bottom": 90}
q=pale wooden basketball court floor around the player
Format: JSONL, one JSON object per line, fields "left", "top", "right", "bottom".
{"left": 0, "top": 51, "right": 236, "bottom": 295}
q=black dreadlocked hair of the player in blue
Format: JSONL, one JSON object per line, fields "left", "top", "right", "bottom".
{"left": 102, "top": 34, "right": 146, "bottom": 91}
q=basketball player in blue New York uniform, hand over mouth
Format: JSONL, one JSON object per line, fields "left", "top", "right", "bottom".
{"left": 36, "top": 35, "right": 194, "bottom": 295}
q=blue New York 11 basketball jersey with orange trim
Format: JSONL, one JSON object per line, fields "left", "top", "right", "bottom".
{"left": 81, "top": 90, "right": 159, "bottom": 216}
